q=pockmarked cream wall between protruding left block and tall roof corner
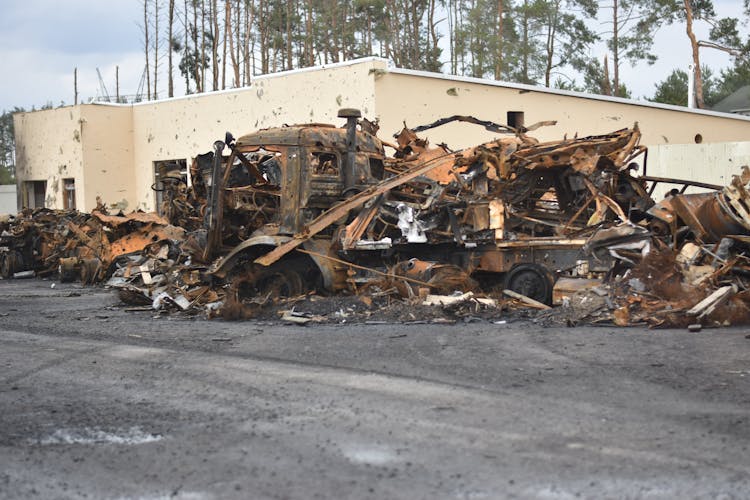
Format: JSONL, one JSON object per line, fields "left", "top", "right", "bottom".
{"left": 133, "top": 59, "right": 385, "bottom": 210}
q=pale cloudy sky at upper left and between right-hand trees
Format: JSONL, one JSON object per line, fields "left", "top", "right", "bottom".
{"left": 0, "top": 0, "right": 741, "bottom": 110}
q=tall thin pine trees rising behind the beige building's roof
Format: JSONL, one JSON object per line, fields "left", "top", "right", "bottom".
{"left": 141, "top": 0, "right": 750, "bottom": 107}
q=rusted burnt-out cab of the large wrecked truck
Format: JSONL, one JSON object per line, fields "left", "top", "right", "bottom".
{"left": 224, "top": 117, "right": 384, "bottom": 235}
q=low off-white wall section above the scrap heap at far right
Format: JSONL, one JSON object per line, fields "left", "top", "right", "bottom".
{"left": 648, "top": 142, "right": 750, "bottom": 200}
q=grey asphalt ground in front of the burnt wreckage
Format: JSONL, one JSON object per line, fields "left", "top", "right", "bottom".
{"left": 0, "top": 280, "right": 750, "bottom": 499}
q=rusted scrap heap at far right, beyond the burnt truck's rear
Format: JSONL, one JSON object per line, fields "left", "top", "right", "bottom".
{"left": 588, "top": 167, "right": 750, "bottom": 327}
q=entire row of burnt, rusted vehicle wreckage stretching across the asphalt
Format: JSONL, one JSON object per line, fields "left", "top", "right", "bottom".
{"left": 0, "top": 109, "right": 750, "bottom": 326}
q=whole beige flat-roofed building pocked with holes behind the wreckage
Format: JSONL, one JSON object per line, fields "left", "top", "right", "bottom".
{"left": 14, "top": 58, "right": 750, "bottom": 211}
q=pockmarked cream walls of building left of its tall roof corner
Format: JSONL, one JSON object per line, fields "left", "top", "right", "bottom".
{"left": 14, "top": 58, "right": 386, "bottom": 211}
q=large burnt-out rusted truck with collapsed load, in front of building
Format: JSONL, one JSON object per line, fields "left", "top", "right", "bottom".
{"left": 179, "top": 109, "right": 653, "bottom": 303}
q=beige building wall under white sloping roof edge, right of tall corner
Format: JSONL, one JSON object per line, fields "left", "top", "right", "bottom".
{"left": 375, "top": 69, "right": 750, "bottom": 149}
